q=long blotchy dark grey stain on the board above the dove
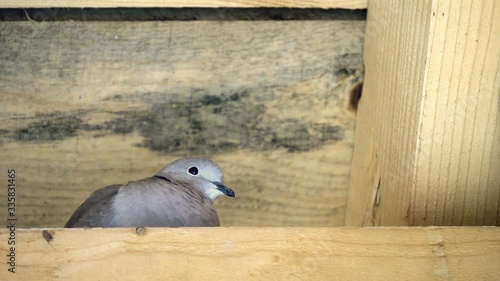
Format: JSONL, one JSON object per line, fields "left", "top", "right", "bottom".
{"left": 1, "top": 89, "right": 343, "bottom": 153}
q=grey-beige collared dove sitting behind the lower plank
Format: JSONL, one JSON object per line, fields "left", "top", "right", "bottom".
{"left": 64, "top": 158, "right": 234, "bottom": 227}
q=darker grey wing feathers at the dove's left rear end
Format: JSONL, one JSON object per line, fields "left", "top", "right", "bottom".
{"left": 64, "top": 184, "right": 123, "bottom": 228}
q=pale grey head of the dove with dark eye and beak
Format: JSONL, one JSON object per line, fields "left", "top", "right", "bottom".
{"left": 156, "top": 158, "right": 235, "bottom": 201}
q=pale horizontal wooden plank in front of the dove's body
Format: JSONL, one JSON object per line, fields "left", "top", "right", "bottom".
{"left": 0, "top": 227, "right": 500, "bottom": 280}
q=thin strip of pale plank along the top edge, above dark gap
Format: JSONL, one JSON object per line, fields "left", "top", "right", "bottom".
{"left": 0, "top": 0, "right": 368, "bottom": 9}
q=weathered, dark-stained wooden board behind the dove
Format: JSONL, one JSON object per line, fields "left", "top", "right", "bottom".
{"left": 0, "top": 21, "right": 364, "bottom": 227}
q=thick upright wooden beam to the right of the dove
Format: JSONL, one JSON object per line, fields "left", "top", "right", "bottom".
{"left": 346, "top": 0, "right": 500, "bottom": 226}
